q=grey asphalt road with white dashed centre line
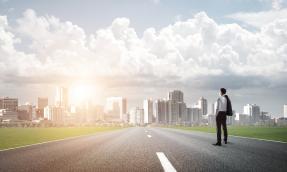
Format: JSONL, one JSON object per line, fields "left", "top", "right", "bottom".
{"left": 0, "top": 127, "right": 287, "bottom": 172}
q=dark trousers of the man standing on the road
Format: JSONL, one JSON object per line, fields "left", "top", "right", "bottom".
{"left": 216, "top": 111, "right": 227, "bottom": 143}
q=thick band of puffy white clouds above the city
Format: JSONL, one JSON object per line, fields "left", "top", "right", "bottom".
{"left": 0, "top": 10, "right": 287, "bottom": 88}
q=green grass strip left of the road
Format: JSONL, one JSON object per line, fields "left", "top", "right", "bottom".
{"left": 0, "top": 127, "right": 125, "bottom": 150}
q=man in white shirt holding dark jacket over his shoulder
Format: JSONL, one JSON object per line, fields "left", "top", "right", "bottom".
{"left": 214, "top": 88, "right": 232, "bottom": 146}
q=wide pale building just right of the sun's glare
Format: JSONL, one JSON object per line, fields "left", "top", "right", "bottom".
{"left": 105, "top": 97, "right": 127, "bottom": 121}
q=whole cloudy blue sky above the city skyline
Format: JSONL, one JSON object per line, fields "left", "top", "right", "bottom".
{"left": 0, "top": 0, "right": 287, "bottom": 117}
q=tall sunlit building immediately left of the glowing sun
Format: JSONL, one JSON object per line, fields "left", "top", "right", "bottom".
{"left": 55, "top": 87, "right": 69, "bottom": 108}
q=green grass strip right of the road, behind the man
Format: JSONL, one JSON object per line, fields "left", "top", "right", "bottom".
{"left": 168, "top": 126, "right": 287, "bottom": 142}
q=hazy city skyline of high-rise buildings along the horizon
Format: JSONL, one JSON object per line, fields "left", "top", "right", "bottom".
{"left": 0, "top": 87, "right": 286, "bottom": 126}
